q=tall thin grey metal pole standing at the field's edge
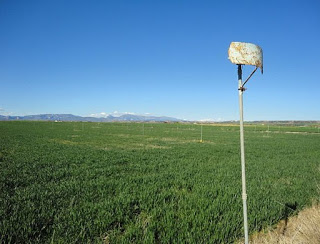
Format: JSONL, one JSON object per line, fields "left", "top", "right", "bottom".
{"left": 238, "top": 64, "right": 249, "bottom": 244}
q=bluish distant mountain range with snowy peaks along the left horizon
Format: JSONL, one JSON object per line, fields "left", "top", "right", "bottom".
{"left": 0, "top": 114, "right": 184, "bottom": 122}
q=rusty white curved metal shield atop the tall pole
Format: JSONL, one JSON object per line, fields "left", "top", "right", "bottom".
{"left": 228, "top": 42, "right": 263, "bottom": 73}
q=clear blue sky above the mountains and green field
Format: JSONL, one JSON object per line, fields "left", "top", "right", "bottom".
{"left": 0, "top": 0, "right": 320, "bottom": 120}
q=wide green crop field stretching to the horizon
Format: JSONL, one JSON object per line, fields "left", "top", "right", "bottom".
{"left": 0, "top": 121, "right": 320, "bottom": 243}
